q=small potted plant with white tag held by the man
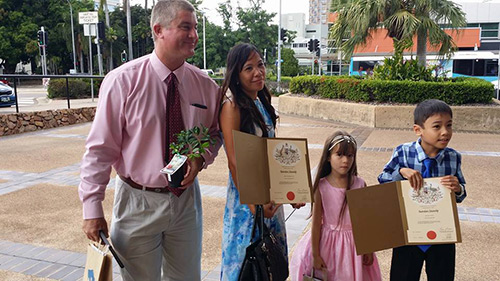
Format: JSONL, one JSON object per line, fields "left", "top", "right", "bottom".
{"left": 162, "top": 125, "right": 215, "bottom": 187}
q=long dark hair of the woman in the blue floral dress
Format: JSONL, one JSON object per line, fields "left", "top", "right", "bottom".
{"left": 221, "top": 43, "right": 277, "bottom": 137}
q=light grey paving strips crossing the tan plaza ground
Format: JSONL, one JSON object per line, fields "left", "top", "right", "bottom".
{"left": 0, "top": 117, "right": 500, "bottom": 281}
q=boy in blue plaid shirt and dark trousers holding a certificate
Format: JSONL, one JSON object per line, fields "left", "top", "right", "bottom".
{"left": 378, "top": 99, "right": 467, "bottom": 281}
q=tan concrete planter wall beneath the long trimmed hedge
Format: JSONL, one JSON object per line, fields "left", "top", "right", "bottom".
{"left": 279, "top": 94, "right": 500, "bottom": 133}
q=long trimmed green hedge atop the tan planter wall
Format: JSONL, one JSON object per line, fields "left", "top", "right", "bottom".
{"left": 290, "top": 76, "right": 493, "bottom": 105}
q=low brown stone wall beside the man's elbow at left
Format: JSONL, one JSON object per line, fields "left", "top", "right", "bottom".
{"left": 0, "top": 107, "right": 96, "bottom": 136}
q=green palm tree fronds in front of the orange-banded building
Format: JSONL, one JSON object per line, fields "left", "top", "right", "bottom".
{"left": 330, "top": 0, "right": 466, "bottom": 65}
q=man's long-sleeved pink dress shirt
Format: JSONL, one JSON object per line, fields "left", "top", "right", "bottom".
{"left": 78, "top": 51, "right": 222, "bottom": 219}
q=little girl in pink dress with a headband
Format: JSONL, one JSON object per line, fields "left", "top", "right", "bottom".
{"left": 290, "top": 131, "right": 382, "bottom": 281}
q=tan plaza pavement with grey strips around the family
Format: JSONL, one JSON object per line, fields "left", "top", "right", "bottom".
{"left": 0, "top": 95, "right": 500, "bottom": 281}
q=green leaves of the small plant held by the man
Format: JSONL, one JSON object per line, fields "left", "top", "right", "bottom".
{"left": 170, "top": 125, "right": 215, "bottom": 159}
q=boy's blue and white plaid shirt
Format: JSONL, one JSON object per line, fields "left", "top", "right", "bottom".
{"left": 378, "top": 138, "right": 467, "bottom": 203}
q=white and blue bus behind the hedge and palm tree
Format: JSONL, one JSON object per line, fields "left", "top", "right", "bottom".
{"left": 349, "top": 51, "right": 499, "bottom": 82}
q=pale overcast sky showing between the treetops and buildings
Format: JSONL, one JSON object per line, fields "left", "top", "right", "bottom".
{"left": 130, "top": 0, "right": 309, "bottom": 25}
